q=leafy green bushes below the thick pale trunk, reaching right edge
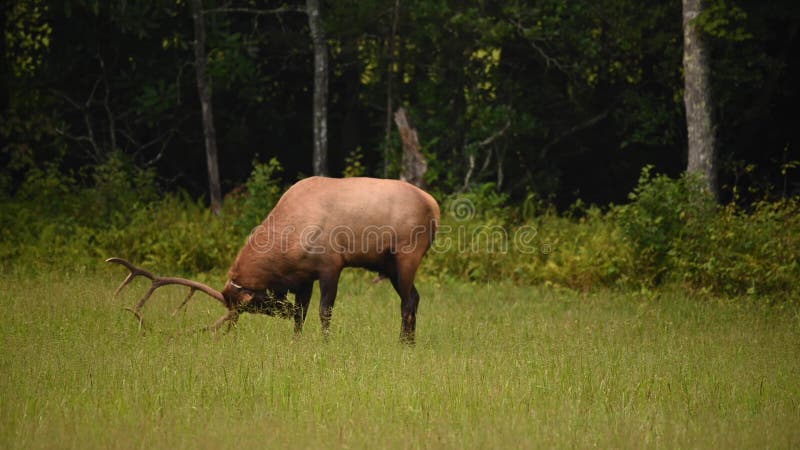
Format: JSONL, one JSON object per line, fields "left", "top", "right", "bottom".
{"left": 614, "top": 168, "right": 800, "bottom": 297}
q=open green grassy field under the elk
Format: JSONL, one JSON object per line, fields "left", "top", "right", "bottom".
{"left": 0, "top": 269, "right": 800, "bottom": 449}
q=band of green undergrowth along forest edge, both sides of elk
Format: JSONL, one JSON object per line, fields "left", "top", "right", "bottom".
{"left": 0, "top": 157, "right": 800, "bottom": 303}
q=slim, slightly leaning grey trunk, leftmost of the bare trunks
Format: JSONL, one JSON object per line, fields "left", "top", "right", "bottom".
{"left": 191, "top": 0, "right": 222, "bottom": 214}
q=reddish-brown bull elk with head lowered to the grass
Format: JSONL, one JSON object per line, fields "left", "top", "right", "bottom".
{"left": 107, "top": 177, "right": 439, "bottom": 342}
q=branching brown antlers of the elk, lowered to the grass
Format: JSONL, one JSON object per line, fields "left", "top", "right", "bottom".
{"left": 106, "top": 258, "right": 233, "bottom": 331}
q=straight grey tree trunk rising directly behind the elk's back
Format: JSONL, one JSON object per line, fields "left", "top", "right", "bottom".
{"left": 306, "top": 0, "right": 328, "bottom": 176}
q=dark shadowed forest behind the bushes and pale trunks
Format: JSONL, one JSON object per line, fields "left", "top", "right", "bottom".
{"left": 0, "top": 0, "right": 800, "bottom": 205}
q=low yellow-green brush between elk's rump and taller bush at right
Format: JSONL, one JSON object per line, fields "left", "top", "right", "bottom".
{"left": 424, "top": 186, "right": 630, "bottom": 290}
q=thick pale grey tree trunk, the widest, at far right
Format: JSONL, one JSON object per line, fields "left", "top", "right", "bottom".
{"left": 683, "top": 0, "right": 717, "bottom": 197}
